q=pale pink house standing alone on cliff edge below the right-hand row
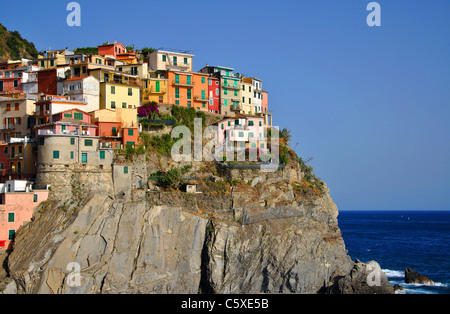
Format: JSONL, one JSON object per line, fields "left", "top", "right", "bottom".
{"left": 215, "top": 113, "right": 267, "bottom": 151}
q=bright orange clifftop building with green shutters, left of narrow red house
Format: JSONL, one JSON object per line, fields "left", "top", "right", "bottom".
{"left": 165, "top": 71, "right": 209, "bottom": 111}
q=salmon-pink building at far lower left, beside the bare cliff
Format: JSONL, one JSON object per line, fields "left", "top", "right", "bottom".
{"left": 0, "top": 180, "right": 48, "bottom": 250}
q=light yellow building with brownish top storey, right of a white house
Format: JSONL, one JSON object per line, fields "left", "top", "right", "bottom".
{"left": 90, "top": 69, "right": 141, "bottom": 110}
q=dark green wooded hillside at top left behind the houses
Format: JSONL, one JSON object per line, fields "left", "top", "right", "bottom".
{"left": 0, "top": 24, "right": 38, "bottom": 60}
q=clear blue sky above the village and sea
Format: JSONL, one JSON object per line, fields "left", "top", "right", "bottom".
{"left": 0, "top": 0, "right": 450, "bottom": 210}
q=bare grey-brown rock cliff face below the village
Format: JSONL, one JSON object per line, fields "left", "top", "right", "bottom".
{"left": 0, "top": 158, "right": 394, "bottom": 293}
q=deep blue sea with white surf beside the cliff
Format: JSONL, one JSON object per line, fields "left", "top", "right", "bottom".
{"left": 338, "top": 211, "right": 450, "bottom": 294}
